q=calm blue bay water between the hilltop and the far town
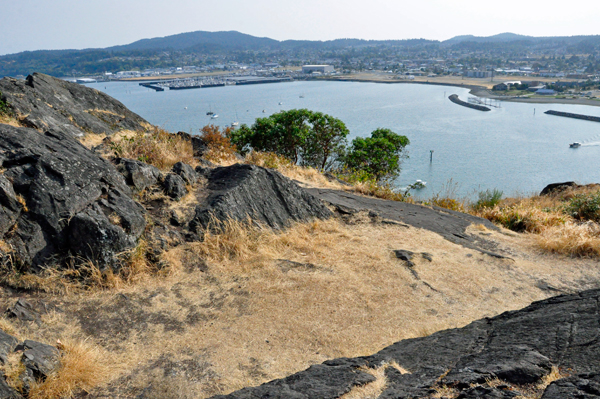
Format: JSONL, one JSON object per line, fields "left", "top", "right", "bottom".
{"left": 89, "top": 82, "right": 600, "bottom": 198}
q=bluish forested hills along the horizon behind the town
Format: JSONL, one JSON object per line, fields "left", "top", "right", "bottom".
{"left": 0, "top": 31, "right": 600, "bottom": 77}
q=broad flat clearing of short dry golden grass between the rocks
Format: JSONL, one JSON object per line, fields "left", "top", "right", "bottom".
{"left": 0, "top": 216, "right": 600, "bottom": 398}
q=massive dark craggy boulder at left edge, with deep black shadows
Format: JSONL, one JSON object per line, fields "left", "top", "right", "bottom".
{"left": 0, "top": 125, "right": 146, "bottom": 271}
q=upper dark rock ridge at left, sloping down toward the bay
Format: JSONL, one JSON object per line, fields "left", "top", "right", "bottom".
{"left": 0, "top": 73, "right": 148, "bottom": 136}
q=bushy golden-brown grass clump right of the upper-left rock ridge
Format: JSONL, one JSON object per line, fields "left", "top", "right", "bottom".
{"left": 111, "top": 127, "right": 197, "bottom": 170}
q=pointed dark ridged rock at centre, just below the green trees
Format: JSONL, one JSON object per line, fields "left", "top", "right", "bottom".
{"left": 190, "top": 164, "right": 332, "bottom": 230}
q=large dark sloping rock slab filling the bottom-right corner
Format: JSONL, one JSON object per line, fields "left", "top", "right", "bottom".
{"left": 214, "top": 289, "right": 600, "bottom": 399}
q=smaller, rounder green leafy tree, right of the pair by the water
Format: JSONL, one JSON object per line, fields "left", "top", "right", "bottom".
{"left": 344, "top": 128, "right": 410, "bottom": 181}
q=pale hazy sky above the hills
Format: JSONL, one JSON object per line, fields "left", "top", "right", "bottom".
{"left": 0, "top": 0, "right": 600, "bottom": 54}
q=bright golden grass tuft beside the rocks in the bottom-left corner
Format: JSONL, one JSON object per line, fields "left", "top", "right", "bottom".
{"left": 28, "top": 341, "right": 110, "bottom": 399}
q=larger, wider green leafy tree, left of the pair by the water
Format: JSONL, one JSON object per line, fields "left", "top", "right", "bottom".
{"left": 230, "top": 109, "right": 349, "bottom": 170}
